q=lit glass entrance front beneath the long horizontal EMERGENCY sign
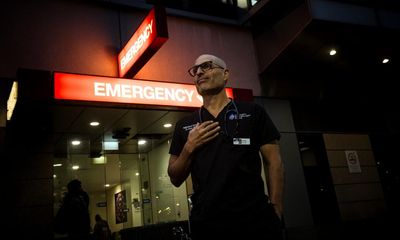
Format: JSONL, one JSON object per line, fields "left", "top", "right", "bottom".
{"left": 53, "top": 110, "right": 189, "bottom": 237}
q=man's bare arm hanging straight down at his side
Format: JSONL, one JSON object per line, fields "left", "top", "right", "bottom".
{"left": 260, "top": 141, "right": 284, "bottom": 218}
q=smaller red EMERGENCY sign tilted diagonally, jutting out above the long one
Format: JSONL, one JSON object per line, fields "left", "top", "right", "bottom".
{"left": 118, "top": 6, "right": 168, "bottom": 77}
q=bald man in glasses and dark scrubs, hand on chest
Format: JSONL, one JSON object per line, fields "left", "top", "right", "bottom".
{"left": 168, "top": 54, "right": 284, "bottom": 240}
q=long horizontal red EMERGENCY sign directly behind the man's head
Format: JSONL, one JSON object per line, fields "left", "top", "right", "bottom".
{"left": 54, "top": 72, "right": 232, "bottom": 107}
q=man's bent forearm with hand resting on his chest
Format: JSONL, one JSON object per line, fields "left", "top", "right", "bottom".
{"left": 168, "top": 121, "right": 220, "bottom": 187}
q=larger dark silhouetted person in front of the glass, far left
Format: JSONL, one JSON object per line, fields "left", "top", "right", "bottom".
{"left": 59, "top": 179, "right": 90, "bottom": 240}
